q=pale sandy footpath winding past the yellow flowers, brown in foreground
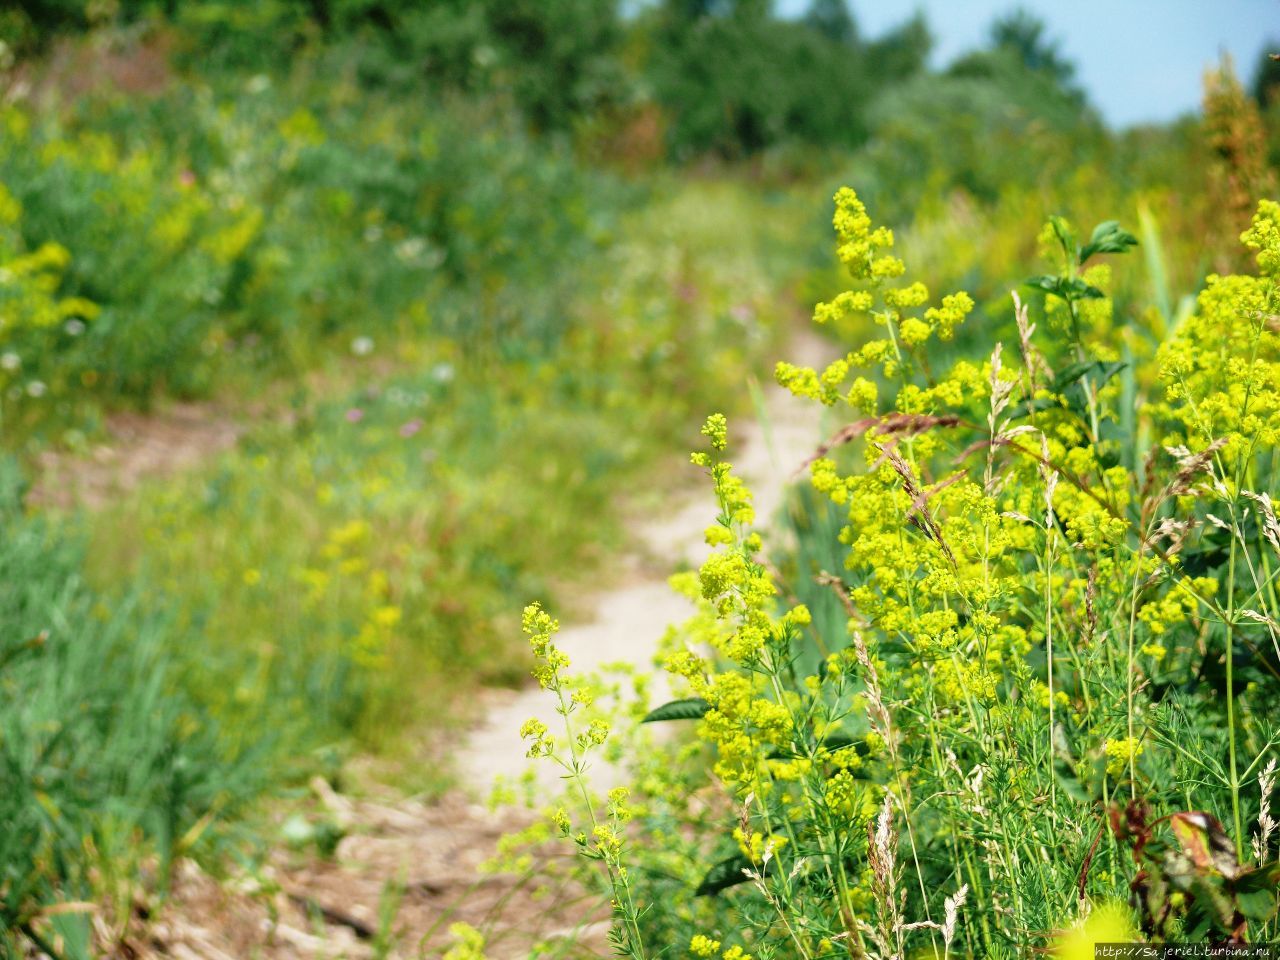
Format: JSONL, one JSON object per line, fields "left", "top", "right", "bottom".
{"left": 253, "top": 334, "right": 835, "bottom": 960}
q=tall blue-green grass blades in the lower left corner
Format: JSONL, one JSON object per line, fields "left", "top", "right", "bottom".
{"left": 0, "top": 461, "right": 263, "bottom": 957}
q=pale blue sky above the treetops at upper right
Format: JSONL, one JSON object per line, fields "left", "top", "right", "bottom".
{"left": 778, "top": 0, "right": 1280, "bottom": 125}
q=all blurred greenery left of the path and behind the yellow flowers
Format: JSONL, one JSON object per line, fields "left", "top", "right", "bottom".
{"left": 0, "top": 0, "right": 1280, "bottom": 937}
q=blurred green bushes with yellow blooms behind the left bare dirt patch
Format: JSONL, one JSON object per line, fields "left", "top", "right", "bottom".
{"left": 0, "top": 70, "right": 624, "bottom": 439}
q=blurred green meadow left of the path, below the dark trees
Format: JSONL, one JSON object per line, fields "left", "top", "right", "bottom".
{"left": 0, "top": 37, "right": 824, "bottom": 957}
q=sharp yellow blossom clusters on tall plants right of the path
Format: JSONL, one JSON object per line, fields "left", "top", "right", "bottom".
{"left": 640, "top": 189, "right": 1280, "bottom": 957}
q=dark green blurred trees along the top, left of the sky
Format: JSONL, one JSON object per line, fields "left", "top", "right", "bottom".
{"left": 10, "top": 0, "right": 929, "bottom": 159}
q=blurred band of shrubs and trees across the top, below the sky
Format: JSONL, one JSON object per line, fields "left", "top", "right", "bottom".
{"left": 0, "top": 0, "right": 1277, "bottom": 443}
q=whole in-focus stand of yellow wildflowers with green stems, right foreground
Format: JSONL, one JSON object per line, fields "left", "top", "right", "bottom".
{"left": 512, "top": 192, "right": 1280, "bottom": 960}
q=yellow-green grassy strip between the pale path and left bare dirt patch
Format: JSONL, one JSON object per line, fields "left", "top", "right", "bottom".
{"left": 64, "top": 171, "right": 801, "bottom": 773}
